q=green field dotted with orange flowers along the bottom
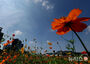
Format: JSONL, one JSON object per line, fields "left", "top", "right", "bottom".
{"left": 0, "top": 50, "right": 90, "bottom": 64}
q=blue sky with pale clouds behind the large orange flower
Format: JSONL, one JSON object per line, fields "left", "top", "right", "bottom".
{"left": 0, "top": 0, "right": 90, "bottom": 51}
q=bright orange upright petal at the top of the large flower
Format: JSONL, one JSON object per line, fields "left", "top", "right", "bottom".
{"left": 67, "top": 9, "right": 82, "bottom": 20}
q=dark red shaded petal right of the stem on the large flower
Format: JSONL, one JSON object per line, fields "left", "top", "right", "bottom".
{"left": 71, "top": 22, "right": 87, "bottom": 32}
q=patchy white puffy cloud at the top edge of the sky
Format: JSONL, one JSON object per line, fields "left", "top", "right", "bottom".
{"left": 33, "top": 0, "right": 54, "bottom": 10}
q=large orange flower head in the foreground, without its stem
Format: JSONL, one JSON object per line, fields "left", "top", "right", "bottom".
{"left": 51, "top": 9, "right": 90, "bottom": 35}
